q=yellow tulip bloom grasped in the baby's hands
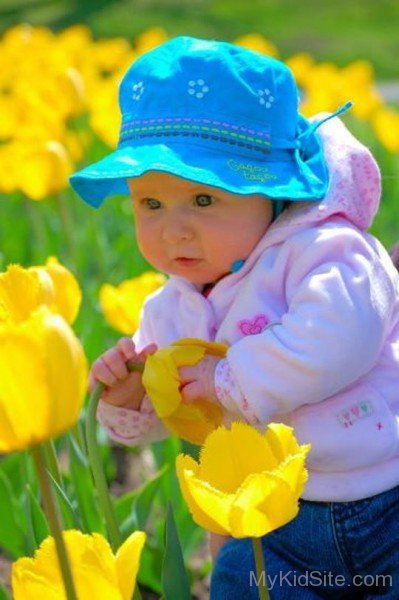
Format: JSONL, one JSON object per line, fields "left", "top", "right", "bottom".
{"left": 143, "top": 338, "right": 227, "bottom": 444}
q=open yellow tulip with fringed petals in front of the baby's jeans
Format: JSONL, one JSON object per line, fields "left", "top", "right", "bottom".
{"left": 176, "top": 423, "right": 310, "bottom": 538}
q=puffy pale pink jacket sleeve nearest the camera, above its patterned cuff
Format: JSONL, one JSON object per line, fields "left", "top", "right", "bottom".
{"left": 227, "top": 226, "right": 395, "bottom": 423}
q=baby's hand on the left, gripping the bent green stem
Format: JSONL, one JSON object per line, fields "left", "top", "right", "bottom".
{"left": 89, "top": 337, "right": 157, "bottom": 410}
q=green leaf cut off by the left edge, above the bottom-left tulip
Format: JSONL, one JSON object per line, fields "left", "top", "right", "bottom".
{"left": 0, "top": 471, "right": 25, "bottom": 559}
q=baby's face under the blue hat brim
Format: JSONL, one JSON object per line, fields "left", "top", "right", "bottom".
{"left": 128, "top": 171, "right": 273, "bottom": 284}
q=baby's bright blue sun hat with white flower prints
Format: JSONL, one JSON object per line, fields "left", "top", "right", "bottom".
{"left": 70, "top": 37, "right": 350, "bottom": 212}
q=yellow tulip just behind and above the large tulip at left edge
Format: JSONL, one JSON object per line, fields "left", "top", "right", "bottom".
{"left": 0, "top": 257, "right": 82, "bottom": 323}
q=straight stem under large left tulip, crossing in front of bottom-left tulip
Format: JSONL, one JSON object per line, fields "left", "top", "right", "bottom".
{"left": 31, "top": 445, "right": 78, "bottom": 600}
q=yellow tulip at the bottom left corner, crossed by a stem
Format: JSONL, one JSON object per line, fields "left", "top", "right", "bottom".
{"left": 12, "top": 529, "right": 146, "bottom": 600}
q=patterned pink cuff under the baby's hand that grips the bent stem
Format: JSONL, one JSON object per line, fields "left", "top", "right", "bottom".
{"left": 97, "top": 396, "right": 165, "bottom": 445}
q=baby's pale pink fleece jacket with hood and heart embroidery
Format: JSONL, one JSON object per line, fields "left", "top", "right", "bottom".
{"left": 98, "top": 118, "right": 399, "bottom": 501}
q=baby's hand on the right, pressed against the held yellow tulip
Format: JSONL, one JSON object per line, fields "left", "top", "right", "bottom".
{"left": 179, "top": 354, "right": 220, "bottom": 402}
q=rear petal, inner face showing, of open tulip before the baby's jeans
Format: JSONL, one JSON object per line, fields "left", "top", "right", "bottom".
{"left": 200, "top": 423, "right": 278, "bottom": 493}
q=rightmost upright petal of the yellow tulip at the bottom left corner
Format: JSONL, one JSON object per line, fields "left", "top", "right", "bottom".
{"left": 115, "top": 531, "right": 146, "bottom": 600}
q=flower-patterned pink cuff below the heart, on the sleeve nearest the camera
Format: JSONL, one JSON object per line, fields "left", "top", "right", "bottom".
{"left": 215, "top": 358, "right": 259, "bottom": 424}
